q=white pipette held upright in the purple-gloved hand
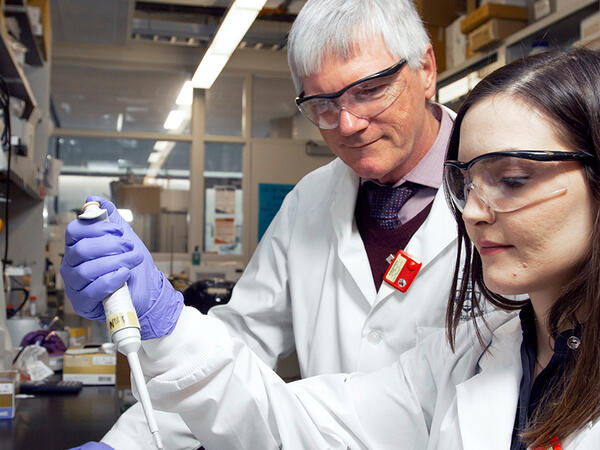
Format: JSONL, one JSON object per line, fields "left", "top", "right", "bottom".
{"left": 79, "top": 202, "right": 164, "bottom": 450}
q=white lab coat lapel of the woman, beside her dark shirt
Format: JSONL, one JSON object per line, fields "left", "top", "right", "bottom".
{"left": 456, "top": 318, "right": 522, "bottom": 450}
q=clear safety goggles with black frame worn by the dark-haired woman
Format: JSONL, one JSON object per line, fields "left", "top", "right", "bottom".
{"left": 444, "top": 150, "right": 595, "bottom": 213}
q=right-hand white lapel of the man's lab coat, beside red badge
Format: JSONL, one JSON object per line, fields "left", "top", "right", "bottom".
{"left": 377, "top": 187, "right": 456, "bottom": 302}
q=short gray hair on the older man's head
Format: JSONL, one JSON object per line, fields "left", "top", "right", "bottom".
{"left": 288, "top": 0, "right": 430, "bottom": 94}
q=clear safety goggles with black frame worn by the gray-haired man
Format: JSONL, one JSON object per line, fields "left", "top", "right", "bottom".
{"left": 296, "top": 59, "right": 406, "bottom": 130}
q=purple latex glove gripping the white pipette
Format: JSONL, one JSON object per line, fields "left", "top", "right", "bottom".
{"left": 60, "top": 196, "right": 183, "bottom": 339}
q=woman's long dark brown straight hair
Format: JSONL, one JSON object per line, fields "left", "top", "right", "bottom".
{"left": 446, "top": 49, "right": 600, "bottom": 447}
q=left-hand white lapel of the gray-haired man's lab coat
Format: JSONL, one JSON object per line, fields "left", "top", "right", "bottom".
{"left": 331, "top": 160, "right": 377, "bottom": 305}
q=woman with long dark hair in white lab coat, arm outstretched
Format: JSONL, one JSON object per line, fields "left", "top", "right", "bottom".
{"left": 68, "top": 50, "right": 600, "bottom": 450}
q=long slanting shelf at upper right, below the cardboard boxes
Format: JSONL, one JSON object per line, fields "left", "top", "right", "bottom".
{"left": 438, "top": 0, "right": 600, "bottom": 89}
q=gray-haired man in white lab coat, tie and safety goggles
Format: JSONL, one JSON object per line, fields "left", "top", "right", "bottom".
{"left": 61, "top": 0, "right": 456, "bottom": 449}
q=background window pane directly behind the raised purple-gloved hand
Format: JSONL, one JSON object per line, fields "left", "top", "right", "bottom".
{"left": 56, "top": 137, "right": 190, "bottom": 253}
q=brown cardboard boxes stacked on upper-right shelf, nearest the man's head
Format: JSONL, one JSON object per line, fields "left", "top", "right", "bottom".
{"left": 460, "top": 3, "right": 527, "bottom": 57}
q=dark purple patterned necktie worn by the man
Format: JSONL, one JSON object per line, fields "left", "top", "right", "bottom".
{"left": 365, "top": 182, "right": 419, "bottom": 230}
